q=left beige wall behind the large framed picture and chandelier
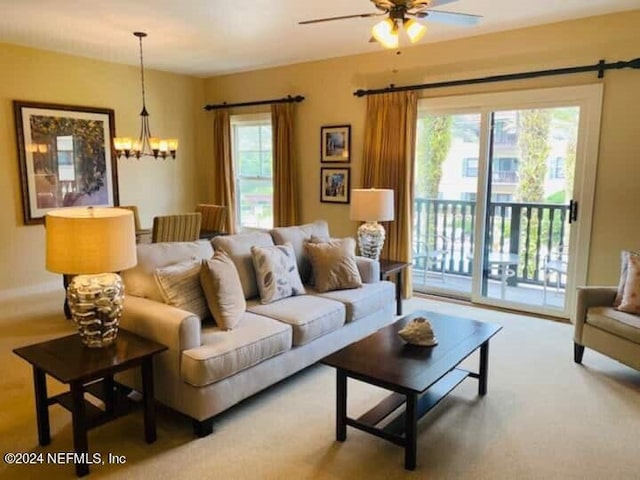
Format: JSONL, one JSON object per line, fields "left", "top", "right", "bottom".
{"left": 0, "top": 44, "right": 205, "bottom": 295}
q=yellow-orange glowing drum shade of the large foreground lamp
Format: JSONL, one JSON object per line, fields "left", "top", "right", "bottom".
{"left": 45, "top": 207, "right": 137, "bottom": 275}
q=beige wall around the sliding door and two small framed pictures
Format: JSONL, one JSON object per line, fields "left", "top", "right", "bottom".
{"left": 205, "top": 10, "right": 640, "bottom": 284}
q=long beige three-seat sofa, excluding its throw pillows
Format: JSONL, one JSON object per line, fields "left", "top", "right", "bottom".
{"left": 118, "top": 221, "right": 395, "bottom": 436}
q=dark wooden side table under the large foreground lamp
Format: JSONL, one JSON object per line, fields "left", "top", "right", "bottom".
{"left": 13, "top": 330, "right": 167, "bottom": 477}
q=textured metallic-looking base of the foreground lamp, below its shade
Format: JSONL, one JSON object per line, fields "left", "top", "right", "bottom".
{"left": 67, "top": 273, "right": 124, "bottom": 348}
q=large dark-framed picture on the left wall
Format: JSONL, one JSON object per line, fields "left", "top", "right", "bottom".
{"left": 13, "top": 100, "right": 119, "bottom": 225}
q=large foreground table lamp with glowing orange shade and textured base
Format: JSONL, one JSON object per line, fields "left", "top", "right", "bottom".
{"left": 45, "top": 207, "right": 137, "bottom": 348}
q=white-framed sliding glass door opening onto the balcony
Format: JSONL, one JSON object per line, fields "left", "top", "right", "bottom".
{"left": 413, "top": 86, "right": 601, "bottom": 317}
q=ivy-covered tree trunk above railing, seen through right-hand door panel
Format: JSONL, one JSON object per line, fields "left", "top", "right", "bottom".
{"left": 516, "top": 108, "right": 551, "bottom": 202}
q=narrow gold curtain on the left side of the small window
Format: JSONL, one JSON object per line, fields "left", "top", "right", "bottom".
{"left": 213, "top": 109, "right": 236, "bottom": 233}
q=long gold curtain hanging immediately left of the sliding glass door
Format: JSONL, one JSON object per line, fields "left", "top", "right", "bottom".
{"left": 363, "top": 92, "right": 418, "bottom": 298}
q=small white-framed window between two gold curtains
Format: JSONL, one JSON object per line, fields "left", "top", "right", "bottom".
{"left": 231, "top": 113, "right": 273, "bottom": 228}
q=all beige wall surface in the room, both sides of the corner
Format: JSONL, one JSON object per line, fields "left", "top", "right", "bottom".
{"left": 0, "top": 10, "right": 640, "bottom": 295}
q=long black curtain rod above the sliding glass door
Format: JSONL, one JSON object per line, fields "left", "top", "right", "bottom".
{"left": 353, "top": 57, "right": 640, "bottom": 97}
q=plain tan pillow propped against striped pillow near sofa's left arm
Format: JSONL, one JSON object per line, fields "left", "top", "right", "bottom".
{"left": 200, "top": 252, "right": 247, "bottom": 330}
